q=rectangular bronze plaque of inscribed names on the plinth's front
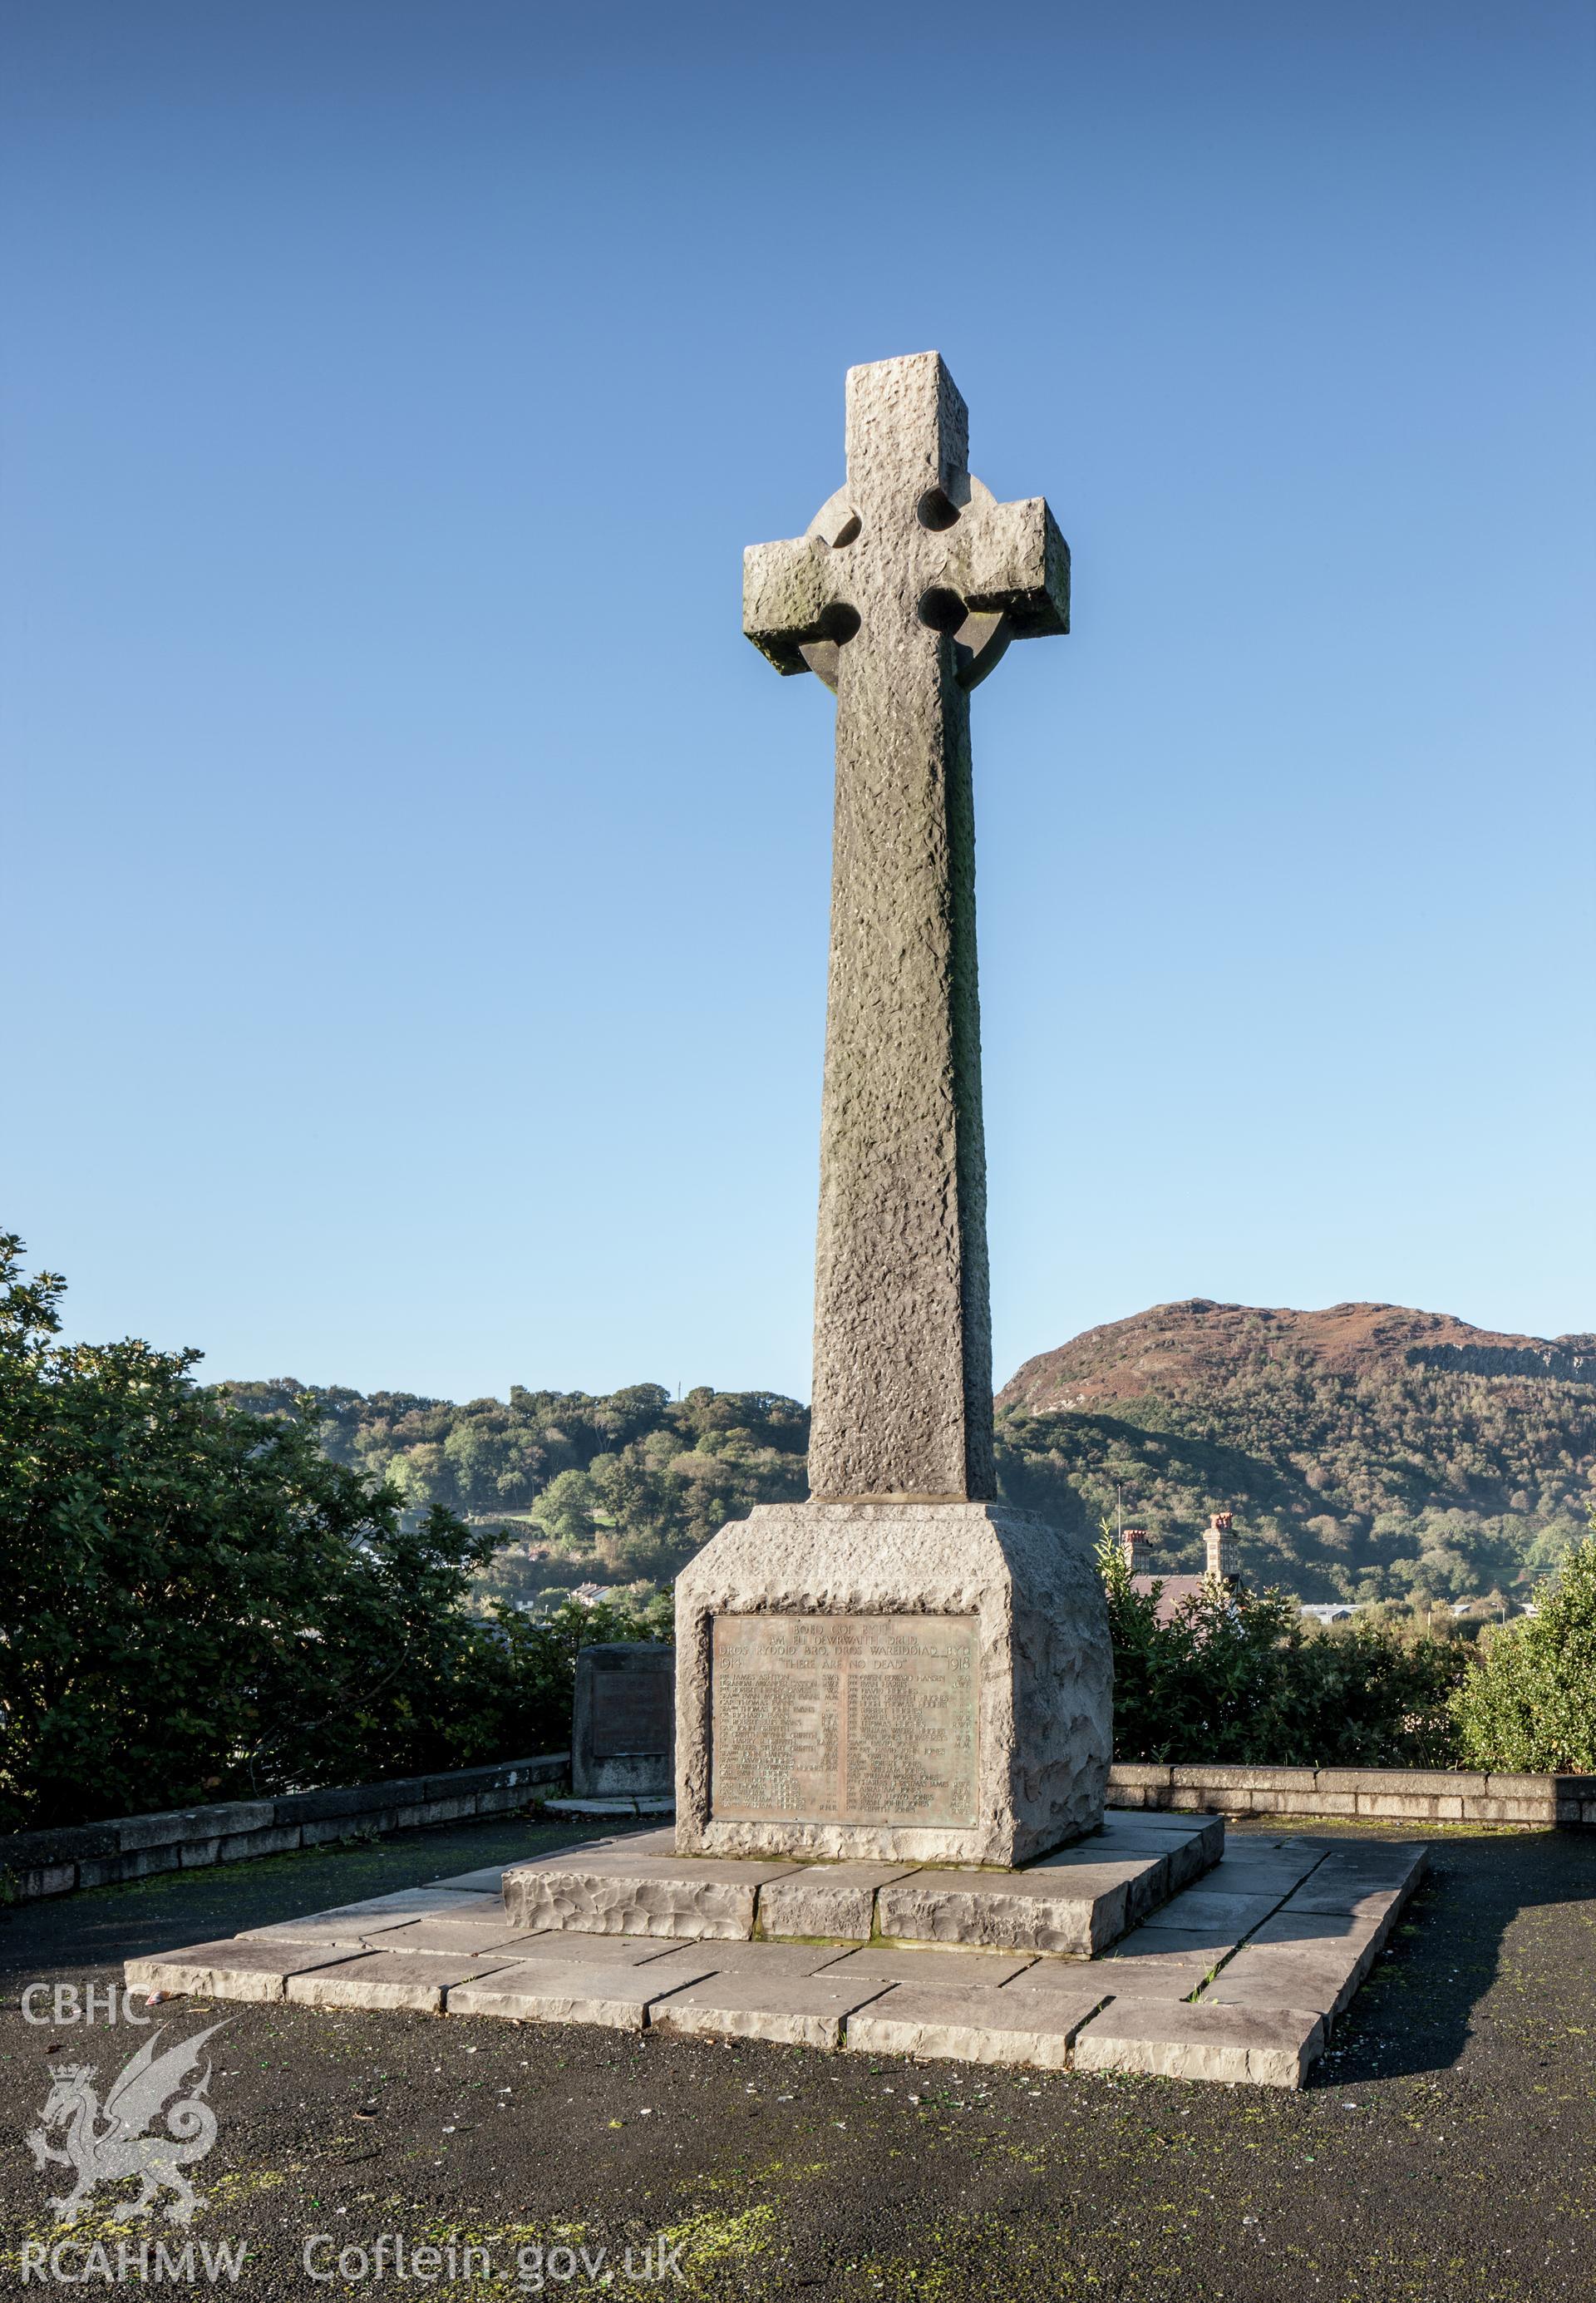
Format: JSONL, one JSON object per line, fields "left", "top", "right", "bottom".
{"left": 709, "top": 1615, "right": 977, "bottom": 1827}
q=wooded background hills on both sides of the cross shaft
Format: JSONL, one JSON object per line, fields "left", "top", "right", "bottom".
{"left": 226, "top": 1299, "right": 1596, "bottom": 1600}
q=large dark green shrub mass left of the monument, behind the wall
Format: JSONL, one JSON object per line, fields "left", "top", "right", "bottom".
{"left": 0, "top": 1235, "right": 661, "bottom": 1828}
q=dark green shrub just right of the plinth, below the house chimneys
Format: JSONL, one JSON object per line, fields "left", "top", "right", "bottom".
{"left": 1099, "top": 1541, "right": 1465, "bottom": 1767}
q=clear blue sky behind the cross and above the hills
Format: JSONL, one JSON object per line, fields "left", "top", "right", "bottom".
{"left": 0, "top": 0, "right": 1596, "bottom": 1398}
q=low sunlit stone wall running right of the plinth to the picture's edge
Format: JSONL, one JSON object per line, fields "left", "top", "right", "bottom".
{"left": 1108, "top": 1764, "right": 1596, "bottom": 1831}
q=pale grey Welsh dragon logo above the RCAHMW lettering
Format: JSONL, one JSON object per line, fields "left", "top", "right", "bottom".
{"left": 27, "top": 2022, "right": 224, "bottom": 2222}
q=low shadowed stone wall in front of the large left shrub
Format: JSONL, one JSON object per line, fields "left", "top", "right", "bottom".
{"left": 0, "top": 1750, "right": 571, "bottom": 1902}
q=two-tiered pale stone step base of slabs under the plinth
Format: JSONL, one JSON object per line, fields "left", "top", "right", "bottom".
{"left": 126, "top": 1842, "right": 1426, "bottom": 2087}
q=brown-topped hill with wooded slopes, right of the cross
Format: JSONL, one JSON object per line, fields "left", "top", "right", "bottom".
{"left": 998, "top": 1297, "right": 1596, "bottom": 1603}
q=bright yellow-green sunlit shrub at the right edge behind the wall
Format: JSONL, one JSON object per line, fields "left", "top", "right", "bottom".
{"left": 1451, "top": 1516, "right": 1596, "bottom": 1776}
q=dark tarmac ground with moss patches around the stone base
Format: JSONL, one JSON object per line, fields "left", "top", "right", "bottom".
{"left": 0, "top": 1822, "right": 1596, "bottom": 2303}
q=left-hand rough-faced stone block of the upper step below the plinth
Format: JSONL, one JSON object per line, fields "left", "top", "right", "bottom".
{"left": 505, "top": 1849, "right": 799, "bottom": 1941}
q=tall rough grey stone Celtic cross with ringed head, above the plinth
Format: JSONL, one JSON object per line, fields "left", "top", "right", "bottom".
{"left": 744, "top": 353, "right": 1069, "bottom": 1502}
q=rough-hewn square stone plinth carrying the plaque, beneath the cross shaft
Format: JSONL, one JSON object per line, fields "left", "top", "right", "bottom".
{"left": 677, "top": 1502, "right": 1112, "bottom": 1866}
